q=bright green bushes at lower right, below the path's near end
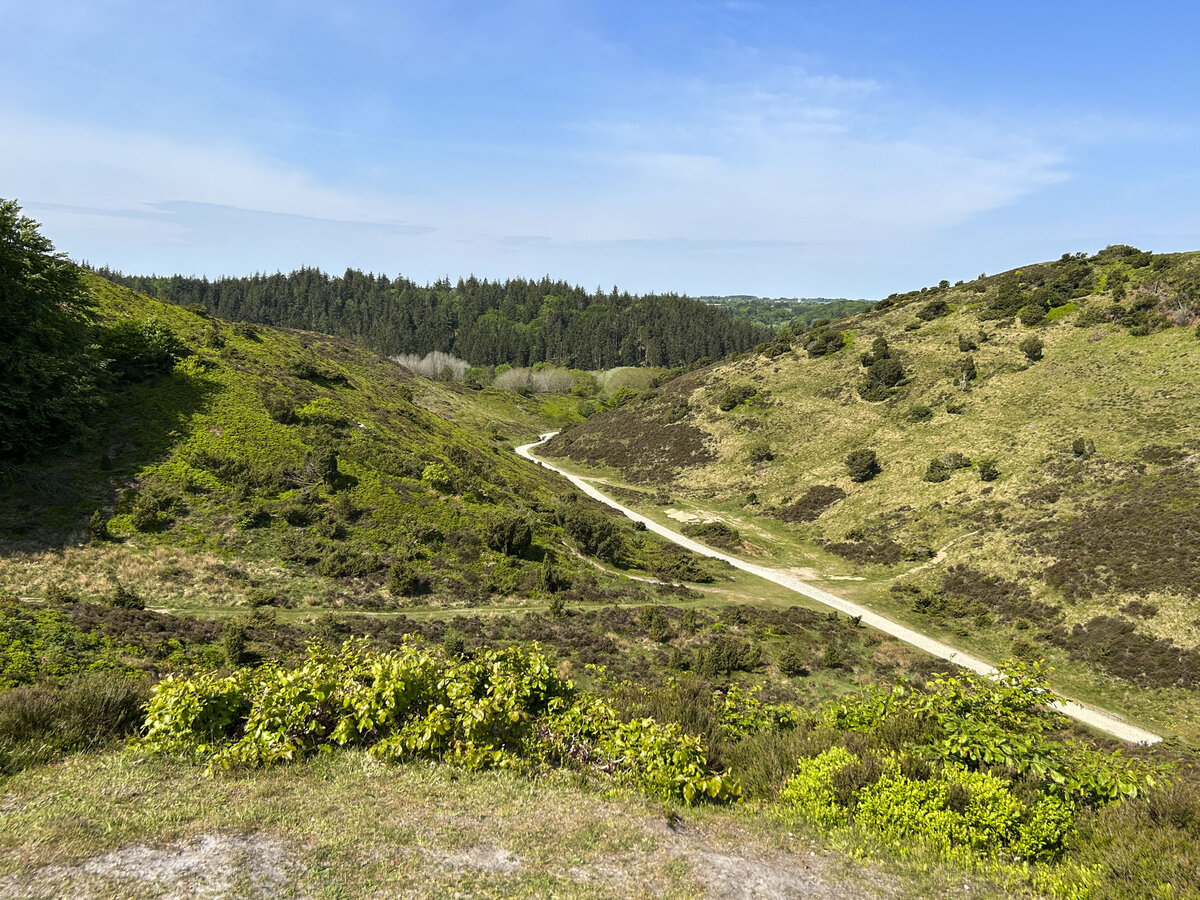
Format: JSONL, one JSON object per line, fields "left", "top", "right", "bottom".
{"left": 780, "top": 664, "right": 1162, "bottom": 860}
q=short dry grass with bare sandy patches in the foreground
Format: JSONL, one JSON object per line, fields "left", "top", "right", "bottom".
{"left": 0, "top": 752, "right": 1032, "bottom": 898}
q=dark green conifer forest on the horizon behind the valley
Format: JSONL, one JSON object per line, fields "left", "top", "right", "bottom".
{"left": 98, "top": 269, "right": 770, "bottom": 370}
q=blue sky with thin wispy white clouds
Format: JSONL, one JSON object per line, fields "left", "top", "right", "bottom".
{"left": 0, "top": 0, "right": 1200, "bottom": 298}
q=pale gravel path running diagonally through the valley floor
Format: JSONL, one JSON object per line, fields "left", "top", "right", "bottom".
{"left": 516, "top": 431, "right": 1163, "bottom": 744}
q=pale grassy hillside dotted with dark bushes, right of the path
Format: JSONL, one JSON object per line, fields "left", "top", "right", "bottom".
{"left": 547, "top": 247, "right": 1200, "bottom": 734}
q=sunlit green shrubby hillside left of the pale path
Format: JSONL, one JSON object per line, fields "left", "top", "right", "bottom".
{"left": 0, "top": 276, "right": 729, "bottom": 610}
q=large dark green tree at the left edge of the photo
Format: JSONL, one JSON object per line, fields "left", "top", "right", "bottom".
{"left": 0, "top": 199, "right": 94, "bottom": 458}
